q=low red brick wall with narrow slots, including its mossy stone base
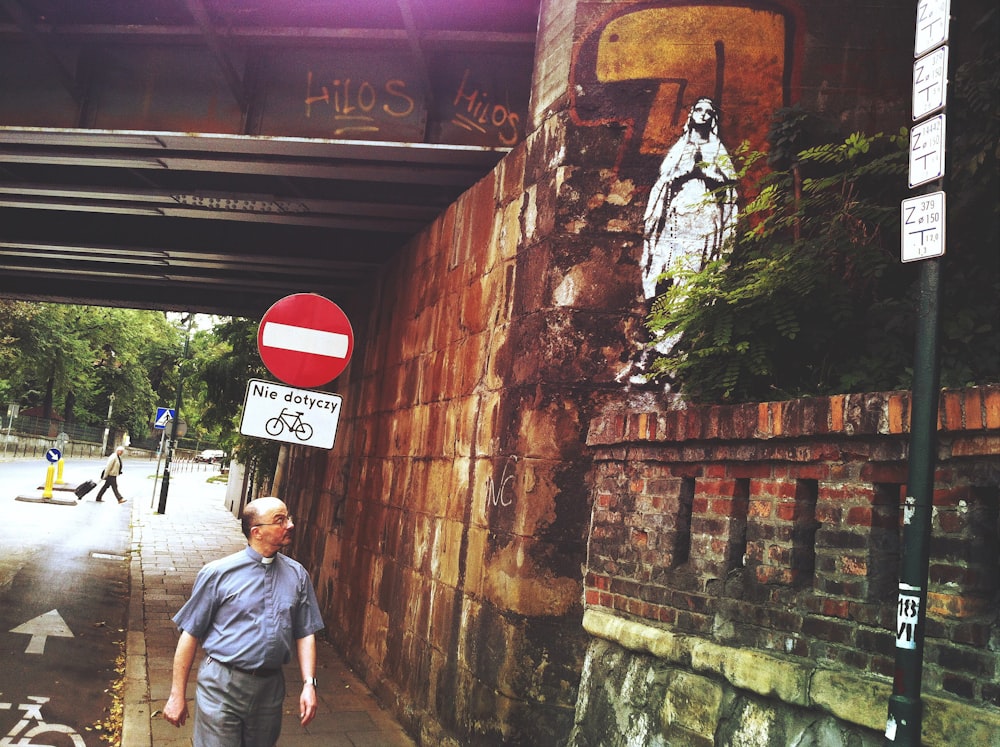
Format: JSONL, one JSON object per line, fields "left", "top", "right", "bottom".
{"left": 570, "top": 386, "right": 1000, "bottom": 747}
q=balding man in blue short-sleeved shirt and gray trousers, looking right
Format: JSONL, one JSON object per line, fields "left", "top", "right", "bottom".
{"left": 163, "top": 497, "right": 323, "bottom": 747}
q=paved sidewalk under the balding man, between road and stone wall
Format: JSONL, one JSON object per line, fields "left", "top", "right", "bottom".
{"left": 122, "top": 470, "right": 414, "bottom": 747}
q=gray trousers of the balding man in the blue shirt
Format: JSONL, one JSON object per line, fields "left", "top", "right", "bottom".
{"left": 194, "top": 656, "right": 285, "bottom": 747}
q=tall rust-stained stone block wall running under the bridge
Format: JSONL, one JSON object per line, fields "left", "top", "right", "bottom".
{"left": 284, "top": 111, "right": 600, "bottom": 745}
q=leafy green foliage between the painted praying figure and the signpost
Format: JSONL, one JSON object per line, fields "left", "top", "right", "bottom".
{"left": 648, "top": 115, "right": 914, "bottom": 401}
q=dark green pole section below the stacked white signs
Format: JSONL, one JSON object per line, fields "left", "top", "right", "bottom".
{"left": 885, "top": 259, "right": 941, "bottom": 747}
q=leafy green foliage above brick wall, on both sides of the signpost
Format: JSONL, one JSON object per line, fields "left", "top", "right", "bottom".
{"left": 647, "top": 4, "right": 1000, "bottom": 402}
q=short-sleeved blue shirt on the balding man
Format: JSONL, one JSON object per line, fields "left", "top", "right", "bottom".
{"left": 173, "top": 546, "right": 323, "bottom": 669}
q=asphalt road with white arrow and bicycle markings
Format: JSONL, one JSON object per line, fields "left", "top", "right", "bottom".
{"left": 0, "top": 459, "right": 135, "bottom": 747}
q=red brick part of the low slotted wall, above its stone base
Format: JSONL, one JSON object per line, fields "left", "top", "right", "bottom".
{"left": 585, "top": 386, "right": 1000, "bottom": 744}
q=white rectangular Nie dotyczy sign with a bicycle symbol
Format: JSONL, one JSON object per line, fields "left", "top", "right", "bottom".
{"left": 240, "top": 379, "right": 344, "bottom": 449}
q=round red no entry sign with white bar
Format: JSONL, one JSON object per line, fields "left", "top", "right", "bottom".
{"left": 257, "top": 293, "right": 354, "bottom": 387}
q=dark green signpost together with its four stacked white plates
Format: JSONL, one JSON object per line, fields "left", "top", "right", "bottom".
{"left": 885, "top": 0, "right": 950, "bottom": 747}
